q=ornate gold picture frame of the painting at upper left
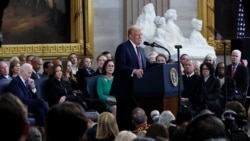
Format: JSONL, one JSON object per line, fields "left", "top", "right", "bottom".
{"left": 0, "top": 0, "right": 94, "bottom": 59}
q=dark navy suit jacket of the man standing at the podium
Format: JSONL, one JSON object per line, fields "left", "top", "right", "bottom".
{"left": 111, "top": 40, "right": 148, "bottom": 97}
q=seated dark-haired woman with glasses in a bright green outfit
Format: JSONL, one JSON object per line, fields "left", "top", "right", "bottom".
{"left": 97, "top": 60, "right": 116, "bottom": 117}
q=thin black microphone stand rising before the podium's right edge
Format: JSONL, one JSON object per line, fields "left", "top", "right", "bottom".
{"left": 175, "top": 45, "right": 182, "bottom": 110}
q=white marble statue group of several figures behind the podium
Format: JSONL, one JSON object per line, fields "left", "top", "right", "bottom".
{"left": 136, "top": 3, "right": 216, "bottom": 61}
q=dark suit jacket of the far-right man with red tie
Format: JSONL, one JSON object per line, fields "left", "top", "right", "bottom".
{"left": 227, "top": 64, "right": 249, "bottom": 95}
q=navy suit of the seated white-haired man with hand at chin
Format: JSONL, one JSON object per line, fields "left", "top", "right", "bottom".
{"left": 8, "top": 76, "right": 48, "bottom": 126}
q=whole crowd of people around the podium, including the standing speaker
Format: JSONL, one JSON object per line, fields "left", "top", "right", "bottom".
{"left": 0, "top": 25, "right": 250, "bottom": 141}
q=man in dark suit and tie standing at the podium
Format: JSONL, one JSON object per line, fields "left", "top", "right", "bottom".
{"left": 111, "top": 25, "right": 148, "bottom": 130}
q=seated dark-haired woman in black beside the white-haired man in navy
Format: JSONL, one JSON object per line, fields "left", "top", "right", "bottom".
{"left": 47, "top": 66, "right": 87, "bottom": 109}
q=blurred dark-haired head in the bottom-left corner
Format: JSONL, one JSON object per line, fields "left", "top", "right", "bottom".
{"left": 0, "top": 93, "right": 30, "bottom": 141}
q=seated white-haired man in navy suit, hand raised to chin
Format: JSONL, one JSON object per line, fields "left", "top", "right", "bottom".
{"left": 8, "top": 63, "right": 48, "bottom": 126}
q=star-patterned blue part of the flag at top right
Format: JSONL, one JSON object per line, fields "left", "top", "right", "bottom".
{"left": 237, "top": 0, "right": 246, "bottom": 38}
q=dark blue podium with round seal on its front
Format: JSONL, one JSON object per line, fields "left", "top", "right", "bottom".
{"left": 134, "top": 63, "right": 183, "bottom": 115}
